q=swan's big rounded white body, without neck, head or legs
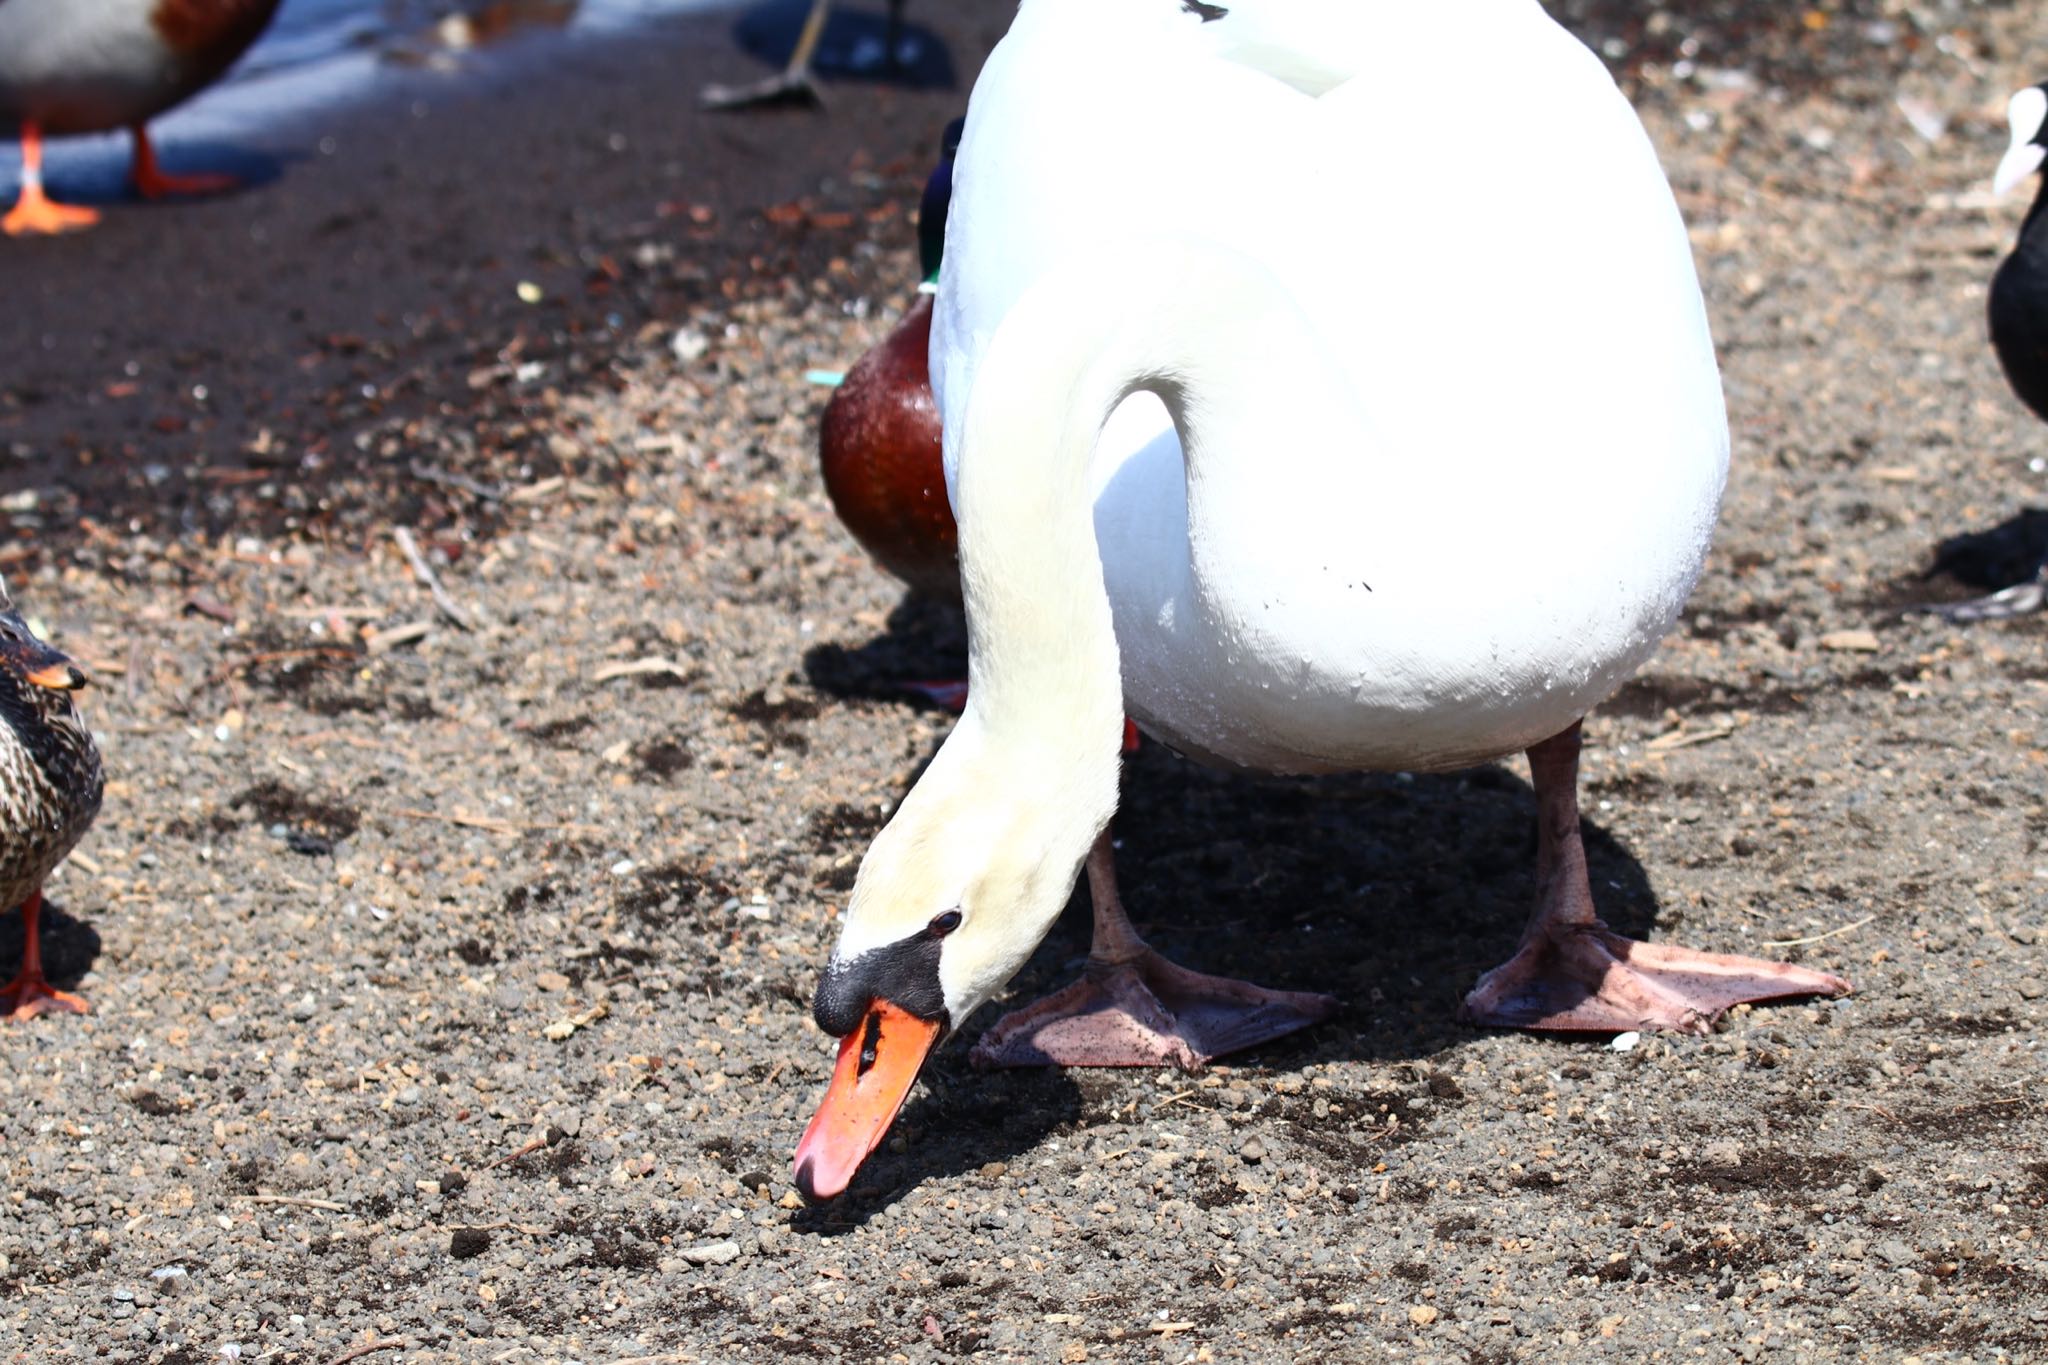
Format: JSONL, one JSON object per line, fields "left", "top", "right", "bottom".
{"left": 932, "top": 0, "right": 1729, "bottom": 772}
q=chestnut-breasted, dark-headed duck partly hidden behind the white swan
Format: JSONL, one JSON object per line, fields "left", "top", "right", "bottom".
{"left": 817, "top": 121, "right": 963, "bottom": 604}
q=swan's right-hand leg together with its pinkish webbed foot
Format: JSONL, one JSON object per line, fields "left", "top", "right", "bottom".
{"left": 1458, "top": 722, "right": 1849, "bottom": 1033}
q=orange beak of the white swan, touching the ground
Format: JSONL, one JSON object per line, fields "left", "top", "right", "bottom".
{"left": 797, "top": 1001, "right": 940, "bottom": 1199}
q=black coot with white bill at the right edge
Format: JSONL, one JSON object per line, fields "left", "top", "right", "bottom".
{"left": 1927, "top": 82, "right": 2048, "bottom": 622}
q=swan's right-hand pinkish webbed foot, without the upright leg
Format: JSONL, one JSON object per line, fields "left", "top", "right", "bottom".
{"left": 1458, "top": 923, "right": 1851, "bottom": 1033}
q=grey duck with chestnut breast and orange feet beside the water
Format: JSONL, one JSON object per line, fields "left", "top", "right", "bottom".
{"left": 0, "top": 0, "right": 276, "bottom": 237}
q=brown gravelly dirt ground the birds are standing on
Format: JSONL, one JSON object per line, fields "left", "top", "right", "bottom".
{"left": 0, "top": 0, "right": 2048, "bottom": 1365}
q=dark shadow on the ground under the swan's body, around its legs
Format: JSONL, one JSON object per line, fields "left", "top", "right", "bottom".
{"left": 1006, "top": 745, "right": 1677, "bottom": 1068}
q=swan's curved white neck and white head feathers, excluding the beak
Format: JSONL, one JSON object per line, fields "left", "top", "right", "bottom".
{"left": 836, "top": 241, "right": 1341, "bottom": 1021}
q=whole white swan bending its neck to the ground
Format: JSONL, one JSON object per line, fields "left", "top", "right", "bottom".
{"left": 795, "top": 0, "right": 1847, "bottom": 1197}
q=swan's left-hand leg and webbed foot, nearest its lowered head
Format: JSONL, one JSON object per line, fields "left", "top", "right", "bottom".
{"left": 973, "top": 831, "right": 1337, "bottom": 1070}
